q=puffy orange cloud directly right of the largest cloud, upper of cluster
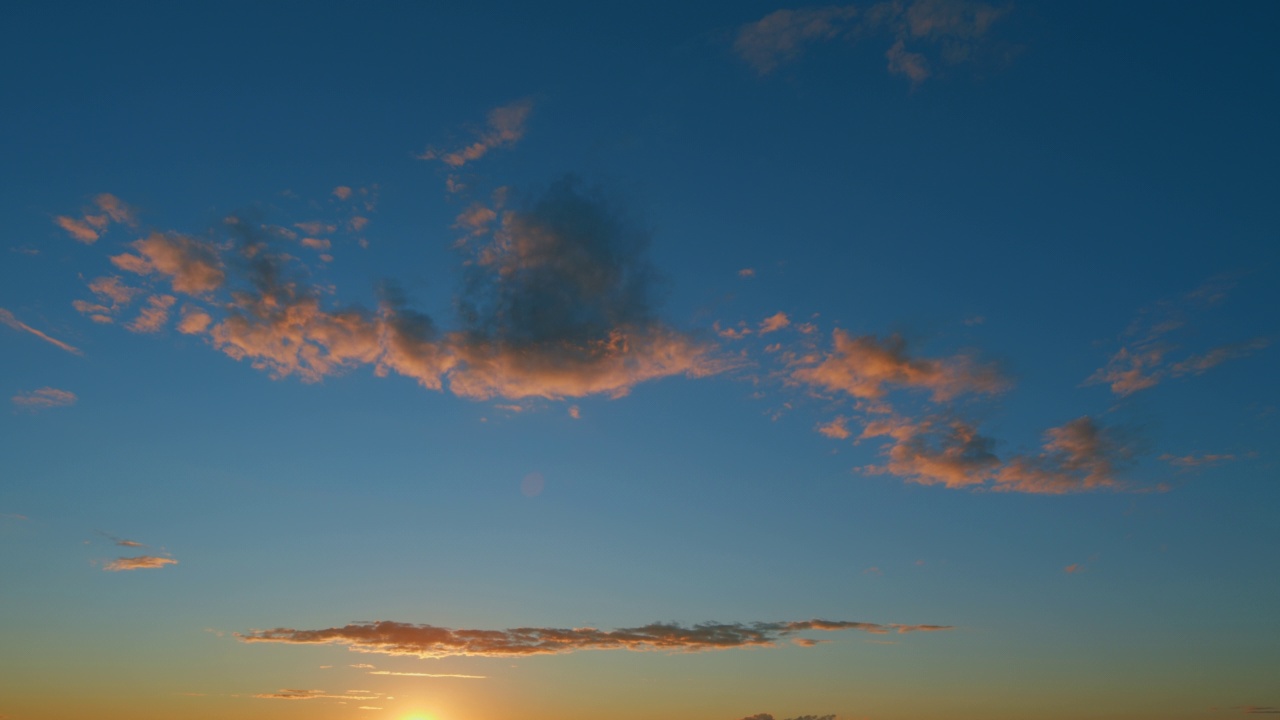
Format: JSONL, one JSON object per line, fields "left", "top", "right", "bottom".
{"left": 792, "top": 329, "right": 1007, "bottom": 401}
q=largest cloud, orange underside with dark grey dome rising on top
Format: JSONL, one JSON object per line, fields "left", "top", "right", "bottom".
{"left": 87, "top": 178, "right": 724, "bottom": 400}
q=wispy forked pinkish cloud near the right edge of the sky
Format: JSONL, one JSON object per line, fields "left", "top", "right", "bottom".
{"left": 1083, "top": 278, "right": 1271, "bottom": 397}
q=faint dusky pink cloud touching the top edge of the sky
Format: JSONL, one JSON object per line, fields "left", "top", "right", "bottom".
{"left": 733, "top": 0, "right": 1006, "bottom": 85}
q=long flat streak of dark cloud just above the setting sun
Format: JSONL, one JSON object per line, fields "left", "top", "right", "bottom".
{"left": 237, "top": 620, "right": 952, "bottom": 657}
